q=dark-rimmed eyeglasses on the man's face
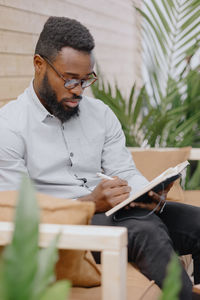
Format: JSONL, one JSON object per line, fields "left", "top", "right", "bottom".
{"left": 40, "top": 55, "right": 98, "bottom": 90}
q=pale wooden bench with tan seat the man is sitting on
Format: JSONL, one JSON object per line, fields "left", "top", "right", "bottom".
{"left": 0, "top": 148, "right": 200, "bottom": 300}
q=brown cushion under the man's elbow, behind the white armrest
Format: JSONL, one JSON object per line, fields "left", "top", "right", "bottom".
{"left": 0, "top": 191, "right": 101, "bottom": 287}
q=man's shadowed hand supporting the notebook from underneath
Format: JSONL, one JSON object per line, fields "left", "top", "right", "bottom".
{"left": 129, "top": 182, "right": 173, "bottom": 212}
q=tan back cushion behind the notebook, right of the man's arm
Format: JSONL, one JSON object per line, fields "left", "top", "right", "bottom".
{"left": 132, "top": 147, "right": 191, "bottom": 202}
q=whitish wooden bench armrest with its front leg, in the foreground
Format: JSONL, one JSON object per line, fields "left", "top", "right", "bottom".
{"left": 0, "top": 222, "right": 127, "bottom": 300}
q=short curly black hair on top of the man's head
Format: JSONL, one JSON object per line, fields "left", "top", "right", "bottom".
{"left": 35, "top": 16, "right": 95, "bottom": 61}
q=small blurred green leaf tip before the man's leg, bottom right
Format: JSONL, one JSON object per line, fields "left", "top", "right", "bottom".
{"left": 160, "top": 254, "right": 181, "bottom": 300}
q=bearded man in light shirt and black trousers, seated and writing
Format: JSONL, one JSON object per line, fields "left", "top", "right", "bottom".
{"left": 0, "top": 17, "right": 200, "bottom": 300}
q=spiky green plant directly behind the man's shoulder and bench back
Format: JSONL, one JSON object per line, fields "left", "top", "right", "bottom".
{"left": 92, "top": 74, "right": 200, "bottom": 147}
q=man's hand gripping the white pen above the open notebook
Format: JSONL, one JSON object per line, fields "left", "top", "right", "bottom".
{"left": 79, "top": 177, "right": 131, "bottom": 212}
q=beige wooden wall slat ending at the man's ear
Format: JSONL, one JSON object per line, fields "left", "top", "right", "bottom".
{"left": 0, "top": 53, "right": 33, "bottom": 77}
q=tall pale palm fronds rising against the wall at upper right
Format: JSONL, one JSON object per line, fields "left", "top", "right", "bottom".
{"left": 136, "top": 0, "right": 200, "bottom": 147}
